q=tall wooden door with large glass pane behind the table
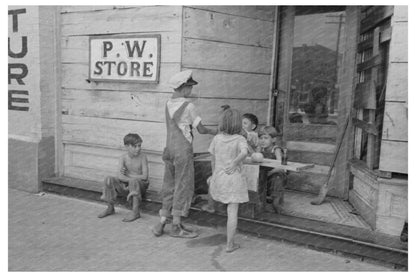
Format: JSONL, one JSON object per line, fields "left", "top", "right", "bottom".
{"left": 274, "top": 6, "right": 346, "bottom": 192}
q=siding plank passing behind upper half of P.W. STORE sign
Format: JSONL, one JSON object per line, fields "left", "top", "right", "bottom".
{"left": 61, "top": 32, "right": 181, "bottom": 63}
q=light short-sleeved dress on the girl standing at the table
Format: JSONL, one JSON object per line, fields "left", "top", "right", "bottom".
{"left": 208, "top": 134, "right": 248, "bottom": 204}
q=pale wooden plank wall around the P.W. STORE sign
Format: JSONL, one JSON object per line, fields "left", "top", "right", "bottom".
{"left": 60, "top": 6, "right": 274, "bottom": 191}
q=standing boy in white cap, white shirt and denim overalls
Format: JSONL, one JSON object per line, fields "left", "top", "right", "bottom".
{"left": 152, "top": 70, "right": 217, "bottom": 238}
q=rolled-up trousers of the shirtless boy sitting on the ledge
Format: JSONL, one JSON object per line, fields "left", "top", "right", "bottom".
{"left": 101, "top": 176, "right": 149, "bottom": 204}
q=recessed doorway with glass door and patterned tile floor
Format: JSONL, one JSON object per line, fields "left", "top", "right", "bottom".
{"left": 266, "top": 6, "right": 369, "bottom": 228}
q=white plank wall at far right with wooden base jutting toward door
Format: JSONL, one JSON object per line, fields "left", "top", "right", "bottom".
{"left": 349, "top": 6, "right": 408, "bottom": 236}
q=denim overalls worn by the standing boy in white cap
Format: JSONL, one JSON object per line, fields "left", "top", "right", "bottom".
{"left": 159, "top": 102, "right": 194, "bottom": 217}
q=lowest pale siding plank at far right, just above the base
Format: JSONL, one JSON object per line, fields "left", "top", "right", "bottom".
{"left": 379, "top": 140, "right": 408, "bottom": 174}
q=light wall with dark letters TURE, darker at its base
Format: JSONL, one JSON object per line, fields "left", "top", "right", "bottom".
{"left": 8, "top": 6, "right": 57, "bottom": 192}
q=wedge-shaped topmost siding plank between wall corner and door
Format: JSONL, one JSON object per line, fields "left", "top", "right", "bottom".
{"left": 189, "top": 6, "right": 274, "bottom": 21}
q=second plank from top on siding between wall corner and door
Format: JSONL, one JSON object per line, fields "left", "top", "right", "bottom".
{"left": 183, "top": 8, "right": 274, "bottom": 48}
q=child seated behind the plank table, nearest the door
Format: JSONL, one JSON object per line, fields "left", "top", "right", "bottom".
{"left": 259, "top": 126, "right": 287, "bottom": 214}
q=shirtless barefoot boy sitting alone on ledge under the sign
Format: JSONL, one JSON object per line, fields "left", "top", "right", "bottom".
{"left": 98, "top": 134, "right": 149, "bottom": 222}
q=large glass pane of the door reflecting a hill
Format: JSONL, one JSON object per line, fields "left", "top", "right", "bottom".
{"left": 289, "top": 7, "right": 345, "bottom": 124}
